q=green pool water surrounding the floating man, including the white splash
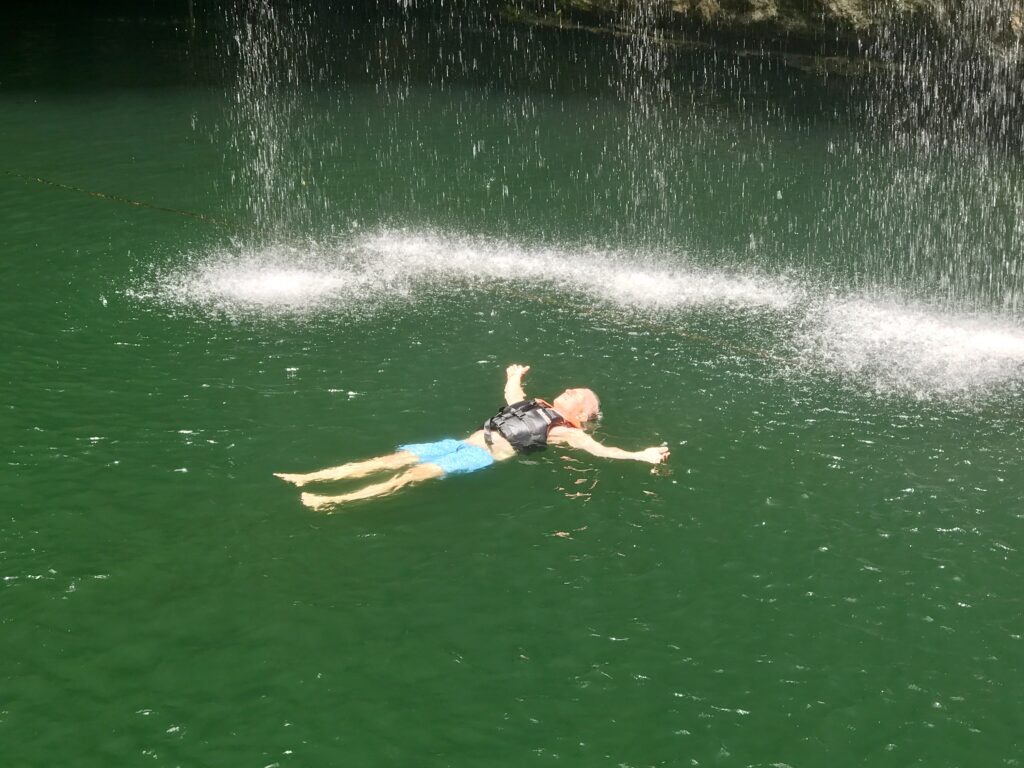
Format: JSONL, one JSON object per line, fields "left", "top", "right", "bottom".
{"left": 0, "top": 11, "right": 1024, "bottom": 767}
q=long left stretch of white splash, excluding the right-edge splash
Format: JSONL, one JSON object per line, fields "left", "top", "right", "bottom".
{"left": 132, "top": 230, "right": 795, "bottom": 316}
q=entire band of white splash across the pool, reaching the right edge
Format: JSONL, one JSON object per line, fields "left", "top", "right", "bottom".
{"left": 129, "top": 229, "right": 1024, "bottom": 397}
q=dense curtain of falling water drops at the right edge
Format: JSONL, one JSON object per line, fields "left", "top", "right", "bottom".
{"left": 864, "top": 0, "right": 1024, "bottom": 311}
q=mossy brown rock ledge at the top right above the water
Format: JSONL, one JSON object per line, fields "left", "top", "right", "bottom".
{"left": 503, "top": 0, "right": 1024, "bottom": 74}
